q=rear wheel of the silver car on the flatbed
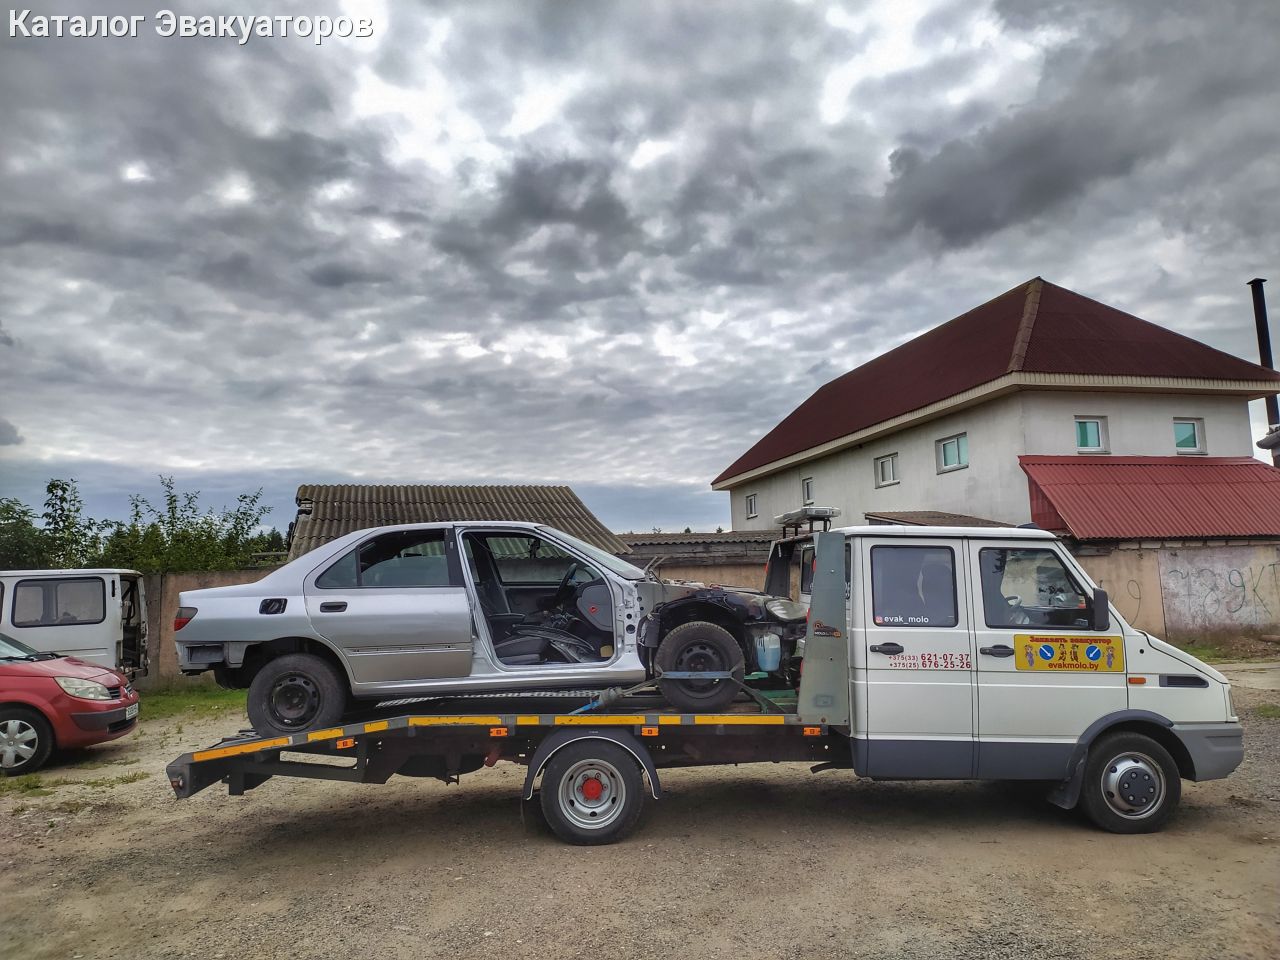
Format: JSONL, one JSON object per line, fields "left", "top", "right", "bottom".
{"left": 246, "top": 653, "right": 347, "bottom": 736}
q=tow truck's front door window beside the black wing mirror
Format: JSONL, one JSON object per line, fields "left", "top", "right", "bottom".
{"left": 978, "top": 547, "right": 1093, "bottom": 628}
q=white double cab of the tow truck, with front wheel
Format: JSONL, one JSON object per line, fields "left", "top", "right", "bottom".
{"left": 799, "top": 526, "right": 1243, "bottom": 832}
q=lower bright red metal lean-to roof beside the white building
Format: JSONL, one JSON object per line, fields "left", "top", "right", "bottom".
{"left": 1018, "top": 456, "right": 1280, "bottom": 540}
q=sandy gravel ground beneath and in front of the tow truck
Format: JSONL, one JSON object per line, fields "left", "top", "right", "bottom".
{"left": 0, "top": 687, "right": 1280, "bottom": 960}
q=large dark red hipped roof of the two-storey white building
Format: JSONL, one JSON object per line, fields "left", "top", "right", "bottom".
{"left": 713, "top": 276, "right": 1280, "bottom": 484}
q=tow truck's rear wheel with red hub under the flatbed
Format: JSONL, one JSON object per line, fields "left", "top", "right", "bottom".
{"left": 539, "top": 740, "right": 644, "bottom": 846}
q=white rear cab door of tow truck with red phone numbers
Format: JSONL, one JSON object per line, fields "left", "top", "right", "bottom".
{"left": 859, "top": 538, "right": 974, "bottom": 780}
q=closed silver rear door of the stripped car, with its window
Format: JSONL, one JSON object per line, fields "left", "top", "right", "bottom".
{"left": 305, "top": 530, "right": 472, "bottom": 684}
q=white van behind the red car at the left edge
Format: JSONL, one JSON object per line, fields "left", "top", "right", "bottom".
{"left": 0, "top": 568, "right": 147, "bottom": 678}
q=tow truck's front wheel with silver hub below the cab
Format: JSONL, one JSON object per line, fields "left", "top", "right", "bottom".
{"left": 1080, "top": 732, "right": 1183, "bottom": 833}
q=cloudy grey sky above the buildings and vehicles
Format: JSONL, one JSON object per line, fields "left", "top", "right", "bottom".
{"left": 0, "top": 0, "right": 1280, "bottom": 530}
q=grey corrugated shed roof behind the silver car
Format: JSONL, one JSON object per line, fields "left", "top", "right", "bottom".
{"left": 289, "top": 484, "right": 631, "bottom": 559}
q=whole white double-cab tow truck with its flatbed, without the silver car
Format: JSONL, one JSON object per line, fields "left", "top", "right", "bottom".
{"left": 168, "top": 526, "right": 1243, "bottom": 845}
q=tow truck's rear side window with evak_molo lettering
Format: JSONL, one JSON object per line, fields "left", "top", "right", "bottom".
{"left": 872, "top": 547, "right": 959, "bottom": 627}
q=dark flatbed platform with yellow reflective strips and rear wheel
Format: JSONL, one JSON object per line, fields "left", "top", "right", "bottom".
{"left": 166, "top": 695, "right": 851, "bottom": 844}
